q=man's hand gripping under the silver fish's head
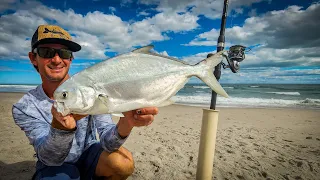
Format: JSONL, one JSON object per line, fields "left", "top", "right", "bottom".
{"left": 51, "top": 106, "right": 87, "bottom": 131}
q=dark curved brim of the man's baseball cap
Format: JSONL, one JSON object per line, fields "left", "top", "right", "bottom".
{"left": 32, "top": 38, "right": 81, "bottom": 52}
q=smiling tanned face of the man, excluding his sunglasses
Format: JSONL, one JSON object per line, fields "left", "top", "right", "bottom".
{"left": 29, "top": 44, "right": 71, "bottom": 81}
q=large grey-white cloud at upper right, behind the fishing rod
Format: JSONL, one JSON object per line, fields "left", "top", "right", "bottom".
{"left": 189, "top": 3, "right": 320, "bottom": 48}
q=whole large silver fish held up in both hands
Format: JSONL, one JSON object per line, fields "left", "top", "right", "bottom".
{"left": 53, "top": 45, "right": 228, "bottom": 117}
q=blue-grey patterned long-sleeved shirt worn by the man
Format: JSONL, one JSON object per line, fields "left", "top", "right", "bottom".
{"left": 12, "top": 85, "right": 126, "bottom": 166}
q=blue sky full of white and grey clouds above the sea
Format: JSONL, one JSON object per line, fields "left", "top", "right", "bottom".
{"left": 0, "top": 0, "right": 320, "bottom": 84}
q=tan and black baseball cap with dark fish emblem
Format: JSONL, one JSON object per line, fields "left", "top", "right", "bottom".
{"left": 31, "top": 25, "right": 81, "bottom": 52}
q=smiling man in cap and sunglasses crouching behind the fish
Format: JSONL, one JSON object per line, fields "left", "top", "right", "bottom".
{"left": 12, "top": 25, "right": 158, "bottom": 180}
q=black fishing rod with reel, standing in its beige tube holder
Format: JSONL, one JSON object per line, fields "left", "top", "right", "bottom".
{"left": 196, "top": 0, "right": 246, "bottom": 180}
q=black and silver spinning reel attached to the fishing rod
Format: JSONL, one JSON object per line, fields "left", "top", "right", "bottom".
{"left": 222, "top": 45, "right": 251, "bottom": 73}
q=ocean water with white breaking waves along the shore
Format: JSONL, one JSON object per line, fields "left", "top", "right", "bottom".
{"left": 0, "top": 84, "right": 320, "bottom": 109}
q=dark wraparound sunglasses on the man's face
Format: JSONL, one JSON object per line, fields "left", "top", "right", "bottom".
{"left": 33, "top": 47, "right": 73, "bottom": 59}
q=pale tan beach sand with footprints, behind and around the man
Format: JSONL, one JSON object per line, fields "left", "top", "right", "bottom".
{"left": 0, "top": 93, "right": 320, "bottom": 180}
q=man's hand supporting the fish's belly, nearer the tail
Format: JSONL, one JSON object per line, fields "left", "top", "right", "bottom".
{"left": 117, "top": 107, "right": 159, "bottom": 137}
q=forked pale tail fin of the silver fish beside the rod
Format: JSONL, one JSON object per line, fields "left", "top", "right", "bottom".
{"left": 195, "top": 51, "right": 229, "bottom": 98}
